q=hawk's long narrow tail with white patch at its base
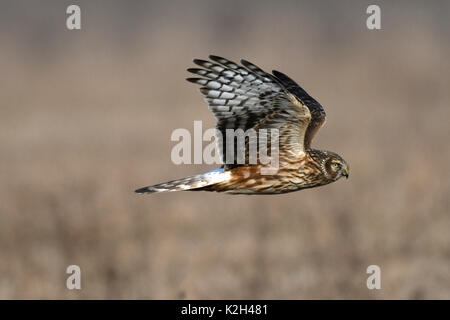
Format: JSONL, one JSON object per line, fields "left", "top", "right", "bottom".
{"left": 135, "top": 168, "right": 230, "bottom": 194}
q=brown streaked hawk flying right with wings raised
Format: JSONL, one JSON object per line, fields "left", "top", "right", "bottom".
{"left": 136, "top": 55, "right": 349, "bottom": 195}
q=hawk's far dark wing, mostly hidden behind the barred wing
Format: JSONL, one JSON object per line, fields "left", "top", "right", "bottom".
{"left": 272, "top": 70, "right": 326, "bottom": 149}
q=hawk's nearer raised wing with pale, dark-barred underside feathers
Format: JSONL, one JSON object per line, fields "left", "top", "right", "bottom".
{"left": 187, "top": 56, "right": 311, "bottom": 168}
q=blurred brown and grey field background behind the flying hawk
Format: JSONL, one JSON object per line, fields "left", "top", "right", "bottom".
{"left": 0, "top": 0, "right": 450, "bottom": 299}
